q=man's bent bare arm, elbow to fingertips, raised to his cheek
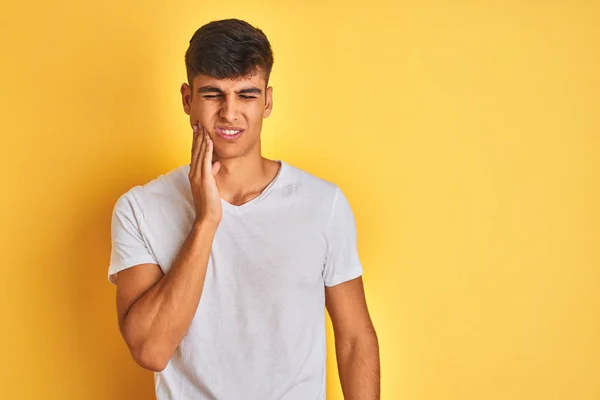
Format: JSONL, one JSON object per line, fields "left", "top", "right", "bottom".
{"left": 117, "top": 125, "right": 222, "bottom": 371}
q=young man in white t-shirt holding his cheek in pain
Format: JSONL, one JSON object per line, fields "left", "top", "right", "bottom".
{"left": 108, "top": 19, "right": 380, "bottom": 400}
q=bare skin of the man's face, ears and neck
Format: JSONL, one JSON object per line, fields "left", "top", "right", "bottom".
{"left": 180, "top": 70, "right": 279, "bottom": 205}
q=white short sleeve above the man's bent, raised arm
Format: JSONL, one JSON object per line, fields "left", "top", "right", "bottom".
{"left": 108, "top": 191, "right": 158, "bottom": 285}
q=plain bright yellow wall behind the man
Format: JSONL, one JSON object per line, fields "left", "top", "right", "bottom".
{"left": 0, "top": 0, "right": 600, "bottom": 400}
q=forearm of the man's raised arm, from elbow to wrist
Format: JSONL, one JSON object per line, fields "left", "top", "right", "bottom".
{"left": 125, "top": 222, "right": 217, "bottom": 369}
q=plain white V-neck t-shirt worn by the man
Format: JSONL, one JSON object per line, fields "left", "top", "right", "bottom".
{"left": 108, "top": 160, "right": 362, "bottom": 400}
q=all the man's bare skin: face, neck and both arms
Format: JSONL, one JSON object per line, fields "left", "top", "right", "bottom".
{"left": 117, "top": 66, "right": 380, "bottom": 400}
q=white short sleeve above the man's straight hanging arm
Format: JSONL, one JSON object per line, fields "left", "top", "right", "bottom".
{"left": 323, "top": 187, "right": 363, "bottom": 286}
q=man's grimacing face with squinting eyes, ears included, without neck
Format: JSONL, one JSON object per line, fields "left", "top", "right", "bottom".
{"left": 181, "top": 72, "right": 273, "bottom": 159}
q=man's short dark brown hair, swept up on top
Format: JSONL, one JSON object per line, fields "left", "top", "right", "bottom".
{"left": 185, "top": 18, "right": 273, "bottom": 89}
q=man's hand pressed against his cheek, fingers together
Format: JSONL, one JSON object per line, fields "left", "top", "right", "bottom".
{"left": 189, "top": 121, "right": 223, "bottom": 224}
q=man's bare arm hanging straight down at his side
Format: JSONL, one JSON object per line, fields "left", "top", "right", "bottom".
{"left": 325, "top": 277, "right": 381, "bottom": 400}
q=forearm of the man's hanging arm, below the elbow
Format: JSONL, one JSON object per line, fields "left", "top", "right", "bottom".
{"left": 336, "top": 333, "right": 380, "bottom": 400}
